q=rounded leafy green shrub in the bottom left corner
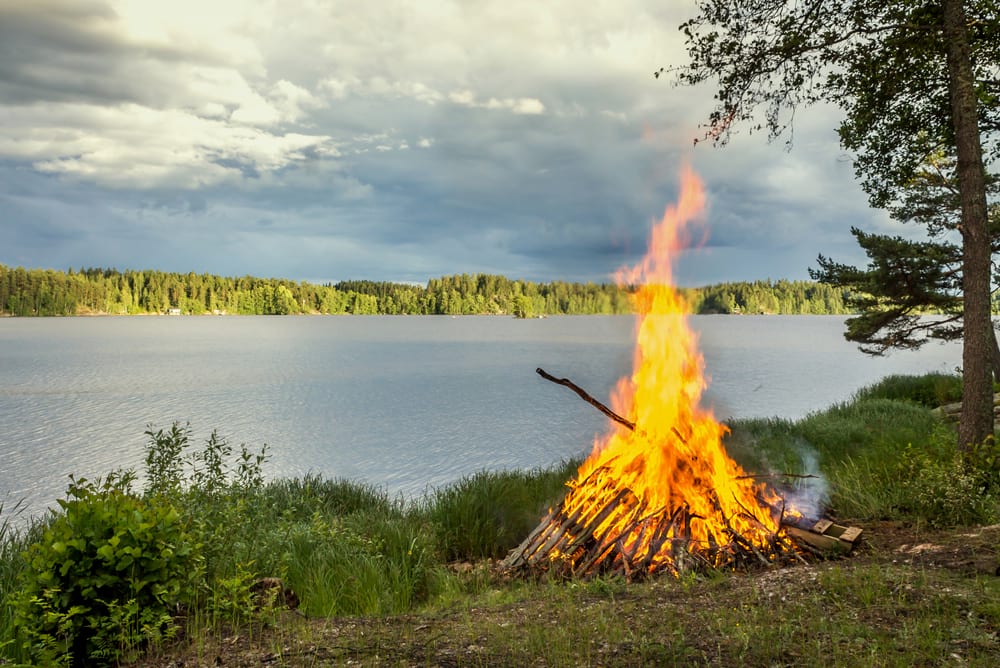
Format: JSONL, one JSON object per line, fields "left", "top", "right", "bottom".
{"left": 14, "top": 473, "right": 201, "bottom": 666}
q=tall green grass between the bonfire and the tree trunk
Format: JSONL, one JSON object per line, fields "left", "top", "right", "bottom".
{"left": 727, "top": 374, "right": 1000, "bottom": 525}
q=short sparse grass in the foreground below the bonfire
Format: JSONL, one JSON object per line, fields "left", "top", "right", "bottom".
{"left": 137, "top": 552, "right": 1000, "bottom": 667}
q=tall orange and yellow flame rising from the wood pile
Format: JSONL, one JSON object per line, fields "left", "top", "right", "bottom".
{"left": 554, "top": 168, "right": 780, "bottom": 572}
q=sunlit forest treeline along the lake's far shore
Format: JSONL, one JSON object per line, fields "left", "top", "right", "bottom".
{"left": 0, "top": 264, "right": 845, "bottom": 317}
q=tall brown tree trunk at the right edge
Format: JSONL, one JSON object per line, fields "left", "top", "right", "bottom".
{"left": 942, "top": 0, "right": 994, "bottom": 451}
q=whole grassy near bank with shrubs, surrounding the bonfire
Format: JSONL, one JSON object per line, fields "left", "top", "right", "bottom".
{"left": 0, "top": 375, "right": 1000, "bottom": 666}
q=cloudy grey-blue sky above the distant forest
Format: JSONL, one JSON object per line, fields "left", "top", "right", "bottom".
{"left": 0, "top": 0, "right": 892, "bottom": 286}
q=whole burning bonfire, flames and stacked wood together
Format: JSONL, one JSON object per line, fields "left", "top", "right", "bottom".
{"left": 503, "top": 170, "right": 844, "bottom": 579}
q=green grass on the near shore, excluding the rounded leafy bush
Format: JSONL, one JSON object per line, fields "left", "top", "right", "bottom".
{"left": 0, "top": 374, "right": 1000, "bottom": 666}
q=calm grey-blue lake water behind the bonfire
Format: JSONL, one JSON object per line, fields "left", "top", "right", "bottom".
{"left": 0, "top": 316, "right": 961, "bottom": 512}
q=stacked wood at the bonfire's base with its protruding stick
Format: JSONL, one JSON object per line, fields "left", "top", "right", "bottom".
{"left": 501, "top": 369, "right": 861, "bottom": 580}
